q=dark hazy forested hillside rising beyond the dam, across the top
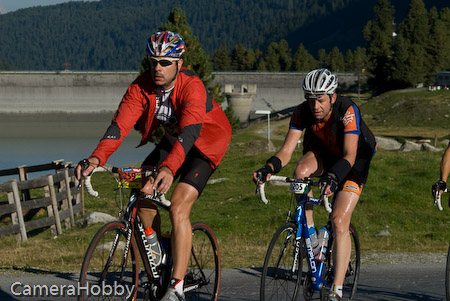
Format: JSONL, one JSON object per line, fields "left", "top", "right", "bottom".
{"left": 0, "top": 0, "right": 445, "bottom": 70}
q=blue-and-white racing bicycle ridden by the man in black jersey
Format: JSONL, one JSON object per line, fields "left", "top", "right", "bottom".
{"left": 257, "top": 175, "right": 360, "bottom": 301}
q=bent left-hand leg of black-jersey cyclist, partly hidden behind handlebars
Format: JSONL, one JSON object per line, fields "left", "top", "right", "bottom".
{"left": 294, "top": 151, "right": 323, "bottom": 225}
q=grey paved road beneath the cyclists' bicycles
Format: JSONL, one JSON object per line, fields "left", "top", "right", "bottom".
{"left": 0, "top": 263, "right": 445, "bottom": 301}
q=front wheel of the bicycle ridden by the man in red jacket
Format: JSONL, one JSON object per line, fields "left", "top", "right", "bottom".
{"left": 78, "top": 222, "right": 139, "bottom": 300}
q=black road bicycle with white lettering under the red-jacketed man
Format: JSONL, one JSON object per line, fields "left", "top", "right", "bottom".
{"left": 78, "top": 167, "right": 221, "bottom": 301}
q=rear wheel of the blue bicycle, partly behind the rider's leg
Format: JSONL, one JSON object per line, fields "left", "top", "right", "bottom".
{"left": 321, "top": 224, "right": 361, "bottom": 300}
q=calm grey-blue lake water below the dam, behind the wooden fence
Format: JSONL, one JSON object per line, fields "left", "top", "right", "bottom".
{"left": 0, "top": 112, "right": 154, "bottom": 179}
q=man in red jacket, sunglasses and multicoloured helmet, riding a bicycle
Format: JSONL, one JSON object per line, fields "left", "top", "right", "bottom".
{"left": 76, "top": 31, "right": 231, "bottom": 300}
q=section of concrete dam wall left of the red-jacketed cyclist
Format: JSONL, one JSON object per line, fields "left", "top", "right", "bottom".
{"left": 0, "top": 73, "right": 137, "bottom": 113}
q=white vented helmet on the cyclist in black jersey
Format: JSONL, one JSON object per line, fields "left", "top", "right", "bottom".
{"left": 303, "top": 68, "right": 338, "bottom": 99}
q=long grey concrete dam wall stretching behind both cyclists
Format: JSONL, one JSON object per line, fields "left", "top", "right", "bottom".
{"left": 0, "top": 72, "right": 356, "bottom": 113}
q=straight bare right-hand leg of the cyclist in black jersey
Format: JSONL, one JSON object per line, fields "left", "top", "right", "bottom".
{"left": 331, "top": 191, "right": 359, "bottom": 285}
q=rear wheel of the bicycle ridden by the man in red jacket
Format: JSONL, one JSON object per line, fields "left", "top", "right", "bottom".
{"left": 184, "top": 222, "right": 221, "bottom": 301}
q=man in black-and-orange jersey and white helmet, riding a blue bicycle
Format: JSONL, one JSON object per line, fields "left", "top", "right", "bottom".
{"left": 253, "top": 68, "right": 376, "bottom": 300}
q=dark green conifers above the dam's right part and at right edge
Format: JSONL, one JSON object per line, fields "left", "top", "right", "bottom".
{"left": 213, "top": 0, "right": 450, "bottom": 92}
